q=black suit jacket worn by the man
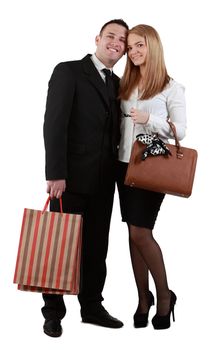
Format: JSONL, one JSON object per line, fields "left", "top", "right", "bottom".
{"left": 44, "top": 55, "right": 119, "bottom": 194}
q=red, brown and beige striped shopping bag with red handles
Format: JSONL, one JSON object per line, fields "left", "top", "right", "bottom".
{"left": 13, "top": 197, "right": 82, "bottom": 294}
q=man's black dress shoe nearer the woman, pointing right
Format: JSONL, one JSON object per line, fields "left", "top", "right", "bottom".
{"left": 81, "top": 305, "right": 124, "bottom": 328}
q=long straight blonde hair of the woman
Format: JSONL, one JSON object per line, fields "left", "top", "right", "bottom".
{"left": 119, "top": 24, "right": 170, "bottom": 100}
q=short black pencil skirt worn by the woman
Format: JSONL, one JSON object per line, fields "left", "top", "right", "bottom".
{"left": 117, "top": 161, "right": 165, "bottom": 230}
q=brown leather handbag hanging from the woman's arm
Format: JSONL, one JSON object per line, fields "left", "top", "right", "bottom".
{"left": 124, "top": 121, "right": 197, "bottom": 198}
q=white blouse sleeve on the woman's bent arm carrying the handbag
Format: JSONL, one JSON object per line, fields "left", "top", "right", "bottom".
{"left": 147, "top": 82, "right": 186, "bottom": 140}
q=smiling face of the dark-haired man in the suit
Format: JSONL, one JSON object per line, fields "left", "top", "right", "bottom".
{"left": 95, "top": 23, "right": 127, "bottom": 68}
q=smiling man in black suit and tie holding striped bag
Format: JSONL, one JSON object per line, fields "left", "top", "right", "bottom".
{"left": 42, "top": 19, "right": 128, "bottom": 337}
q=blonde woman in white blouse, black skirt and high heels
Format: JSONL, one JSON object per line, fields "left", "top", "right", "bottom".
{"left": 118, "top": 24, "right": 186, "bottom": 329}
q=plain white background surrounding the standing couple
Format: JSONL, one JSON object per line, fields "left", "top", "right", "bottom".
{"left": 0, "top": 0, "right": 216, "bottom": 350}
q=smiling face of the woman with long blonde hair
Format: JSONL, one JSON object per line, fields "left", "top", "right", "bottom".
{"left": 127, "top": 33, "right": 148, "bottom": 66}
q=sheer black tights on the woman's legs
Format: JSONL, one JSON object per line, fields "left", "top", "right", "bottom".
{"left": 128, "top": 224, "right": 170, "bottom": 316}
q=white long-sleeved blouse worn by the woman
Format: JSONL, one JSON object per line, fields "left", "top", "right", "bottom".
{"left": 118, "top": 79, "right": 186, "bottom": 163}
